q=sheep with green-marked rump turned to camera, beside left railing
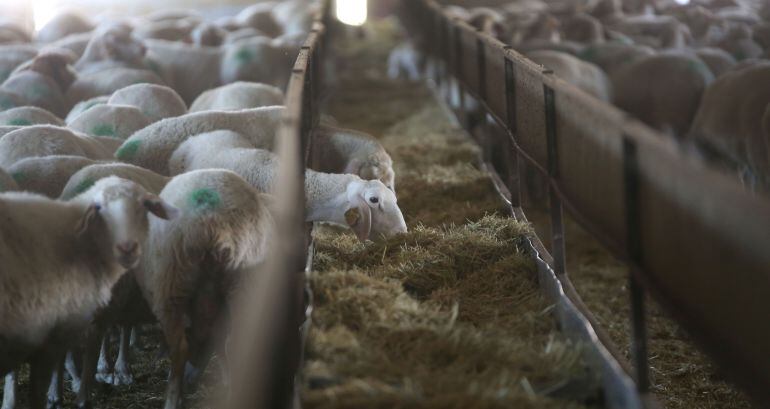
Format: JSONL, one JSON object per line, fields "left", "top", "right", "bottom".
{"left": 136, "top": 169, "right": 274, "bottom": 408}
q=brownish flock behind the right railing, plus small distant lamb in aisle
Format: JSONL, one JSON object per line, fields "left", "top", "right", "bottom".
{"left": 389, "top": 0, "right": 770, "bottom": 191}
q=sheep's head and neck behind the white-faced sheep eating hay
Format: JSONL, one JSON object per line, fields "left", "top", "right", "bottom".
{"left": 313, "top": 124, "right": 396, "bottom": 191}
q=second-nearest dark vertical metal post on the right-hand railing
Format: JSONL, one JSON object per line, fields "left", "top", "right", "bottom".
{"left": 543, "top": 81, "right": 567, "bottom": 275}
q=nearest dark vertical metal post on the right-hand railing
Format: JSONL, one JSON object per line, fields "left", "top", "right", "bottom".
{"left": 623, "top": 136, "right": 650, "bottom": 393}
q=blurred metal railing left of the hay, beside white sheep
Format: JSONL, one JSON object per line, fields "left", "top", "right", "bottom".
{"left": 222, "top": 1, "right": 330, "bottom": 409}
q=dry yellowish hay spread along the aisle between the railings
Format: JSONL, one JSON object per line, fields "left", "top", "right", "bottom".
{"left": 302, "top": 19, "right": 595, "bottom": 409}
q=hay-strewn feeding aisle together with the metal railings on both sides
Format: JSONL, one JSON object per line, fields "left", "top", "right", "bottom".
{"left": 0, "top": 0, "right": 770, "bottom": 408}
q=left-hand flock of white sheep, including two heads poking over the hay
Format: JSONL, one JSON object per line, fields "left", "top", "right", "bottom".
{"left": 0, "top": 0, "right": 406, "bottom": 409}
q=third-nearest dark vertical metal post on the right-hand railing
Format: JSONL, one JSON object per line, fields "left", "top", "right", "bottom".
{"left": 503, "top": 56, "right": 523, "bottom": 207}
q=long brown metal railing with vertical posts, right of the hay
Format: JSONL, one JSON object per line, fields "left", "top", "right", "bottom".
{"left": 404, "top": 0, "right": 770, "bottom": 402}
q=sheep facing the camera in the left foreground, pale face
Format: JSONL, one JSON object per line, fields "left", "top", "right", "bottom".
{"left": 0, "top": 177, "right": 176, "bottom": 408}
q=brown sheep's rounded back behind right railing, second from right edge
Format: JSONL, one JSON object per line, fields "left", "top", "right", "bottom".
{"left": 612, "top": 53, "right": 714, "bottom": 136}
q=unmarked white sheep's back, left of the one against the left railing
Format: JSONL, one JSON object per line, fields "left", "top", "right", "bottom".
{"left": 107, "top": 84, "right": 187, "bottom": 122}
